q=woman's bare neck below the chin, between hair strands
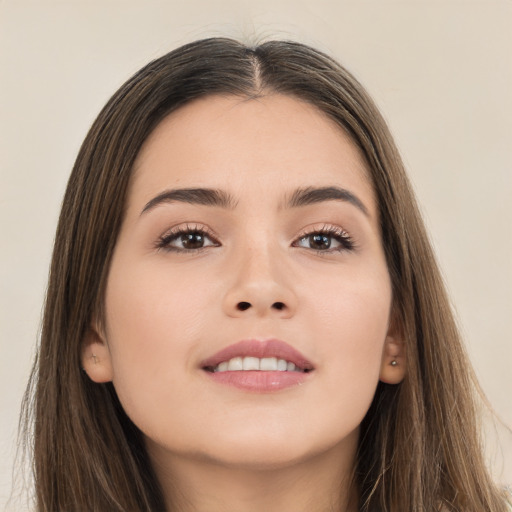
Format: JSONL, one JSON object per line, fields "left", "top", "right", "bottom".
{"left": 148, "top": 432, "right": 357, "bottom": 512}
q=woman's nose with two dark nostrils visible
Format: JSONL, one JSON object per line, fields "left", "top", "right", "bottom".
{"left": 223, "top": 243, "right": 297, "bottom": 318}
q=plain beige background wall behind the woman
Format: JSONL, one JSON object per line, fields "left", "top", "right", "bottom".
{"left": 0, "top": 0, "right": 512, "bottom": 510}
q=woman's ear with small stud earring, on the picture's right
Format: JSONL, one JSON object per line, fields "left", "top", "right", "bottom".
{"left": 380, "top": 313, "right": 406, "bottom": 384}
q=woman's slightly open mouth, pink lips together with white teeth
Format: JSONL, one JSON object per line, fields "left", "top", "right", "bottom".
{"left": 201, "top": 339, "right": 314, "bottom": 392}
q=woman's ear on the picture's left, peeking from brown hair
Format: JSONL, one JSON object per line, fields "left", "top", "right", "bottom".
{"left": 81, "top": 322, "right": 114, "bottom": 383}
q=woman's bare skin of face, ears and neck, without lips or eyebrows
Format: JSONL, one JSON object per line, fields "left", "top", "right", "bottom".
{"left": 83, "top": 95, "right": 405, "bottom": 512}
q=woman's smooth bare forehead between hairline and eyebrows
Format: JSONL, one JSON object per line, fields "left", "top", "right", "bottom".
{"left": 131, "top": 94, "right": 375, "bottom": 215}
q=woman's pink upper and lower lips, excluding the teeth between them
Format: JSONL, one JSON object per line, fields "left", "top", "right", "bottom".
{"left": 200, "top": 339, "right": 314, "bottom": 393}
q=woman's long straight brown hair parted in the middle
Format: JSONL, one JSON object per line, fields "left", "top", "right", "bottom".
{"left": 21, "top": 38, "right": 506, "bottom": 512}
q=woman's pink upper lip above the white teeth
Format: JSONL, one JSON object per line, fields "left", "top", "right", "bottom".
{"left": 201, "top": 338, "right": 314, "bottom": 371}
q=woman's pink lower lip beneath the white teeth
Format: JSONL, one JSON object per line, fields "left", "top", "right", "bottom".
{"left": 206, "top": 370, "right": 310, "bottom": 393}
